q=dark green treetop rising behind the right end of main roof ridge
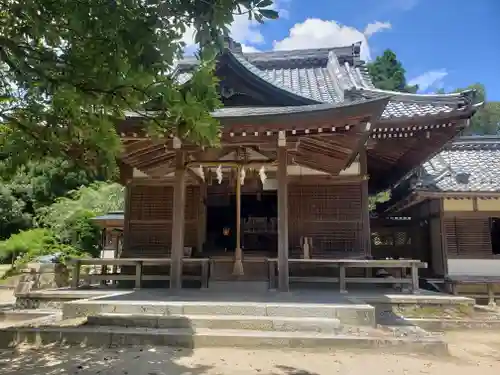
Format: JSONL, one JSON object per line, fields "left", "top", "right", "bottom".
{"left": 367, "top": 49, "right": 418, "bottom": 93}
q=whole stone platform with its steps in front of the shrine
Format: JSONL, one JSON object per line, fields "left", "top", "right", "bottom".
{"left": 0, "top": 289, "right": 474, "bottom": 354}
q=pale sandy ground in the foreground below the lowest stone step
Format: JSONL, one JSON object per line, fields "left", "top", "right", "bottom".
{"left": 0, "top": 331, "right": 500, "bottom": 375}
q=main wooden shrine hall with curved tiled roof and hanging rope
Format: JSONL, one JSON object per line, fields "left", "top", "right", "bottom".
{"left": 111, "top": 40, "right": 477, "bottom": 290}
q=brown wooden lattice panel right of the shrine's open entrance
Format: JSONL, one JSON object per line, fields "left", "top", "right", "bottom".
{"left": 288, "top": 184, "right": 363, "bottom": 257}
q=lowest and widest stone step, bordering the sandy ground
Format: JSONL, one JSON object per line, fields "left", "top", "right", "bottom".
{"left": 0, "top": 326, "right": 448, "bottom": 354}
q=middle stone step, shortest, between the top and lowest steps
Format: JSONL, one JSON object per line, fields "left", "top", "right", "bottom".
{"left": 87, "top": 313, "right": 342, "bottom": 333}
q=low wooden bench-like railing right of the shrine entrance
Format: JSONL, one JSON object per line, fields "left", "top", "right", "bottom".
{"left": 267, "top": 258, "right": 427, "bottom": 293}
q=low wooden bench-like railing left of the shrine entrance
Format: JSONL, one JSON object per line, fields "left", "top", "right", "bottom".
{"left": 70, "top": 258, "right": 210, "bottom": 289}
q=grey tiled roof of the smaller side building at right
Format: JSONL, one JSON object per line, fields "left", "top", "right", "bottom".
{"left": 420, "top": 137, "right": 500, "bottom": 192}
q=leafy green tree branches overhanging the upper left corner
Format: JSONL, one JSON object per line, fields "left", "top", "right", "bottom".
{"left": 0, "top": 0, "right": 278, "bottom": 174}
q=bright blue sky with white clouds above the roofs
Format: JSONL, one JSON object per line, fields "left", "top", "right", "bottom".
{"left": 206, "top": 0, "right": 500, "bottom": 100}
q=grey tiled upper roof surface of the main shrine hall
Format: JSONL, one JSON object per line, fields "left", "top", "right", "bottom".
{"left": 177, "top": 44, "right": 472, "bottom": 121}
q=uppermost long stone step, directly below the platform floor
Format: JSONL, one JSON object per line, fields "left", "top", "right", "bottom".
{"left": 63, "top": 299, "right": 376, "bottom": 327}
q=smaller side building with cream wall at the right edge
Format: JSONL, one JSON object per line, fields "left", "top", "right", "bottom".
{"left": 380, "top": 136, "right": 500, "bottom": 278}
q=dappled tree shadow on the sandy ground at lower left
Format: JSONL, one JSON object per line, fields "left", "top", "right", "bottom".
{"left": 0, "top": 319, "right": 211, "bottom": 375}
